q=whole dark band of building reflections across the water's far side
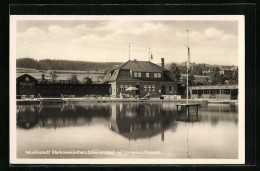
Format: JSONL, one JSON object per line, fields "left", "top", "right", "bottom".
{"left": 17, "top": 103, "right": 238, "bottom": 130}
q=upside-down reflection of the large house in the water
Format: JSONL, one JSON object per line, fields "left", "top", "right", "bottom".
{"left": 110, "top": 103, "right": 177, "bottom": 141}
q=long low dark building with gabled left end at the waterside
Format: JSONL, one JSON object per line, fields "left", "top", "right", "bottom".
{"left": 16, "top": 74, "right": 111, "bottom": 98}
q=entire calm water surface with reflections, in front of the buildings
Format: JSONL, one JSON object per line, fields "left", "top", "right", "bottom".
{"left": 17, "top": 102, "right": 238, "bottom": 158}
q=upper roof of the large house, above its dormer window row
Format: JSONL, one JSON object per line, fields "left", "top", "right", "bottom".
{"left": 112, "top": 60, "right": 169, "bottom": 72}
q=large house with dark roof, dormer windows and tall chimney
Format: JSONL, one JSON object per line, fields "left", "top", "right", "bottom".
{"left": 104, "top": 58, "right": 177, "bottom": 97}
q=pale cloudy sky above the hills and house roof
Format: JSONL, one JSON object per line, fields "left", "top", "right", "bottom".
{"left": 16, "top": 17, "right": 238, "bottom": 65}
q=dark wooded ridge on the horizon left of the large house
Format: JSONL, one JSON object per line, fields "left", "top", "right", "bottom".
{"left": 16, "top": 58, "right": 120, "bottom": 71}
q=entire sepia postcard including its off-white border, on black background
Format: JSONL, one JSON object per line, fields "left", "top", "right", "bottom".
{"left": 10, "top": 15, "right": 245, "bottom": 164}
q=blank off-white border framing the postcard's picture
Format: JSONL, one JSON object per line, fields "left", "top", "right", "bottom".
{"left": 9, "top": 15, "right": 245, "bottom": 164}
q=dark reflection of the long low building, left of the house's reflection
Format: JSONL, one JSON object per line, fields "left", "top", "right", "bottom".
{"left": 17, "top": 104, "right": 111, "bottom": 129}
